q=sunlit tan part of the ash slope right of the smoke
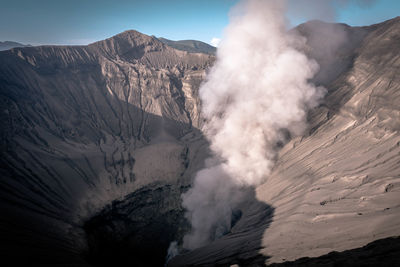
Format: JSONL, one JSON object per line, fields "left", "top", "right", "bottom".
{"left": 257, "top": 17, "right": 400, "bottom": 261}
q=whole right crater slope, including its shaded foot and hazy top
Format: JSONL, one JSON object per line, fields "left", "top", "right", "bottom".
{"left": 170, "top": 17, "right": 400, "bottom": 266}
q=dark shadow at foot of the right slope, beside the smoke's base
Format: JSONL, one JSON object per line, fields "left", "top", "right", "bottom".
{"left": 168, "top": 188, "right": 275, "bottom": 267}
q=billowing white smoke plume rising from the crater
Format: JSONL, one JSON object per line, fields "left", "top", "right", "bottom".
{"left": 182, "top": 0, "right": 325, "bottom": 249}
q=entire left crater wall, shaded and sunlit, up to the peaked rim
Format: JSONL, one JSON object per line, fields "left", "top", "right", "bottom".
{"left": 0, "top": 28, "right": 213, "bottom": 265}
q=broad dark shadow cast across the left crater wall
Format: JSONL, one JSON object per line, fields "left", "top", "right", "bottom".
{"left": 0, "top": 48, "right": 207, "bottom": 266}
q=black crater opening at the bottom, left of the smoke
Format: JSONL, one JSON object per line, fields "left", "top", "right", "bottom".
{"left": 83, "top": 185, "right": 190, "bottom": 266}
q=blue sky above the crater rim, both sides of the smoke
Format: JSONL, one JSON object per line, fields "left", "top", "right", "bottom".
{"left": 0, "top": 0, "right": 400, "bottom": 44}
